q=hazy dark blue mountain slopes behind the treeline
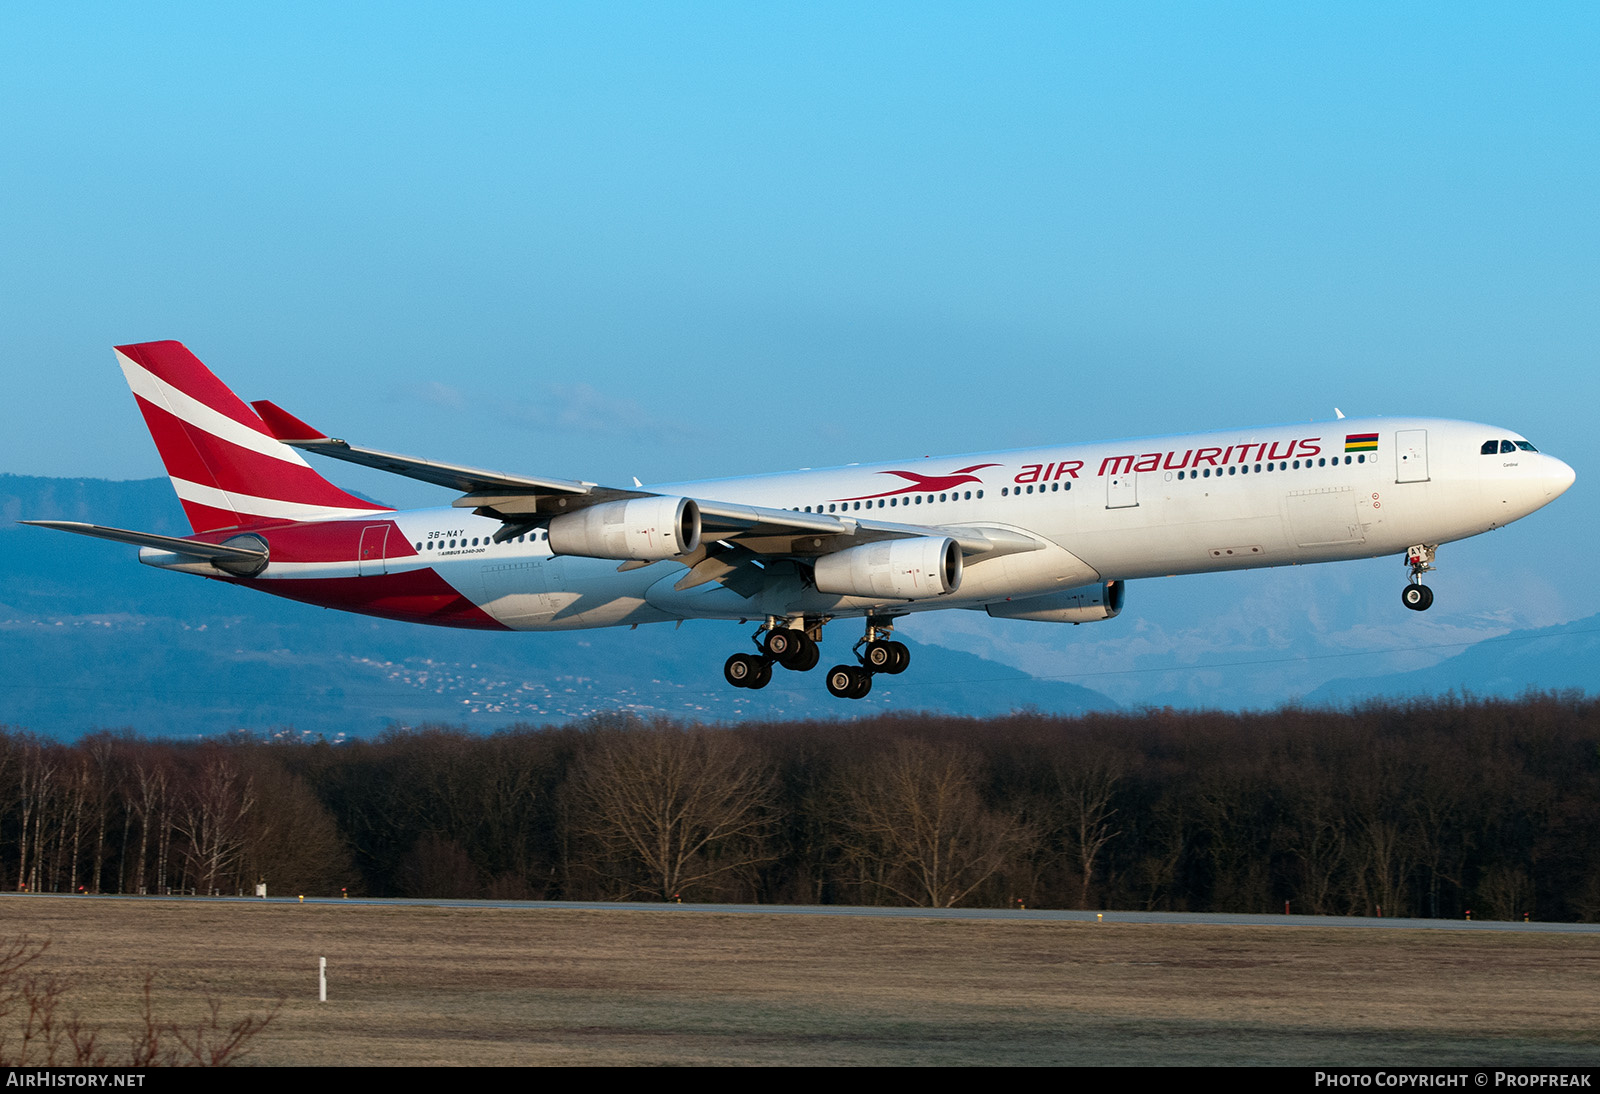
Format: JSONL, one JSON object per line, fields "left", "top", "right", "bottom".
{"left": 0, "top": 475, "right": 1600, "bottom": 737}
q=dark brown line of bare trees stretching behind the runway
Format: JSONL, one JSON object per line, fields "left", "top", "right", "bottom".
{"left": 0, "top": 694, "right": 1600, "bottom": 920}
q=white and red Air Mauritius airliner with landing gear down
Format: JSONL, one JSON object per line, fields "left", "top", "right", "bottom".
{"left": 22, "top": 341, "right": 1574, "bottom": 699}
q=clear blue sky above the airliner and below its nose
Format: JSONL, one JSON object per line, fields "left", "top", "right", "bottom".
{"left": 0, "top": 3, "right": 1600, "bottom": 701}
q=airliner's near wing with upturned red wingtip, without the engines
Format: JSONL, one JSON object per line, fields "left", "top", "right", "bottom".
{"left": 251, "top": 400, "right": 1045, "bottom": 587}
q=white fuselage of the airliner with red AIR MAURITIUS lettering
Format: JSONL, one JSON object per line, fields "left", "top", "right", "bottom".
{"left": 212, "top": 419, "right": 1574, "bottom": 630}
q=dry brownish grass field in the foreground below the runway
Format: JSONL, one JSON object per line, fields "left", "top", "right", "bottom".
{"left": 0, "top": 897, "right": 1600, "bottom": 1065}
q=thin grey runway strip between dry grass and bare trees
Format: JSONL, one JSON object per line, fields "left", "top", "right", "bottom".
{"left": 0, "top": 892, "right": 1600, "bottom": 934}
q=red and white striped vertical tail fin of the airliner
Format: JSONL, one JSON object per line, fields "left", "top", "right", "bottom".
{"left": 117, "top": 342, "right": 387, "bottom": 531}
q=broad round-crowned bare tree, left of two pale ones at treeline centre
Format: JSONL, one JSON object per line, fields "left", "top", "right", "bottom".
{"left": 573, "top": 726, "right": 773, "bottom": 900}
